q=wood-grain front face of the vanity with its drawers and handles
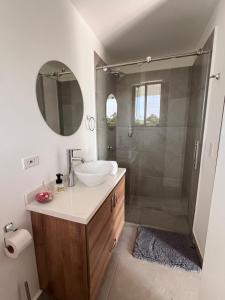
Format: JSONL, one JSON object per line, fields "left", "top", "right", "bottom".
{"left": 86, "top": 178, "right": 125, "bottom": 300}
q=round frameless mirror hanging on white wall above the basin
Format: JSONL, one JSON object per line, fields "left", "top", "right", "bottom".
{"left": 36, "top": 61, "right": 84, "bottom": 136}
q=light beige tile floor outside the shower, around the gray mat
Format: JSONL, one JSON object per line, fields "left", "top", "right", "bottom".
{"left": 97, "top": 223, "right": 201, "bottom": 300}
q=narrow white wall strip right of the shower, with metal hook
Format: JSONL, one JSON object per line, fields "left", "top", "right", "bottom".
{"left": 193, "top": 0, "right": 225, "bottom": 256}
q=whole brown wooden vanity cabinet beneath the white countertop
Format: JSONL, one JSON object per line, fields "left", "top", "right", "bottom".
{"left": 31, "top": 177, "right": 125, "bottom": 300}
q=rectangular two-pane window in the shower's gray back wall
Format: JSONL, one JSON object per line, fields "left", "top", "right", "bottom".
{"left": 134, "top": 83, "right": 162, "bottom": 126}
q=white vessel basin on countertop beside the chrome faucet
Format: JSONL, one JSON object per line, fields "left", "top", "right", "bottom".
{"left": 75, "top": 160, "right": 113, "bottom": 186}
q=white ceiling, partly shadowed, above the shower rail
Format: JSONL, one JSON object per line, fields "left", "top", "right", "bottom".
{"left": 71, "top": 0, "right": 218, "bottom": 62}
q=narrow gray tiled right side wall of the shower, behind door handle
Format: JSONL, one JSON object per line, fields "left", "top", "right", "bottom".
{"left": 183, "top": 34, "right": 214, "bottom": 227}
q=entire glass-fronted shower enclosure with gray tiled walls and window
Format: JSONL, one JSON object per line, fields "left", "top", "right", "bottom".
{"left": 95, "top": 35, "right": 213, "bottom": 232}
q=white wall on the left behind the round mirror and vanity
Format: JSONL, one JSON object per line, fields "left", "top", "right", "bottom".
{"left": 0, "top": 0, "right": 105, "bottom": 300}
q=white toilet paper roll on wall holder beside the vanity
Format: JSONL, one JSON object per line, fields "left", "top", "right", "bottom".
{"left": 5, "top": 229, "right": 32, "bottom": 258}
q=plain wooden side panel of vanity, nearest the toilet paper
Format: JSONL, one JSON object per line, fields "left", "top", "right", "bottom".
{"left": 31, "top": 212, "right": 89, "bottom": 300}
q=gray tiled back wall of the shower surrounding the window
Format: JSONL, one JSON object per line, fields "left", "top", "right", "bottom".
{"left": 116, "top": 67, "right": 191, "bottom": 209}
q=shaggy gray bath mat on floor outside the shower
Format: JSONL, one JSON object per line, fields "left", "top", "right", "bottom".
{"left": 133, "top": 226, "right": 201, "bottom": 272}
